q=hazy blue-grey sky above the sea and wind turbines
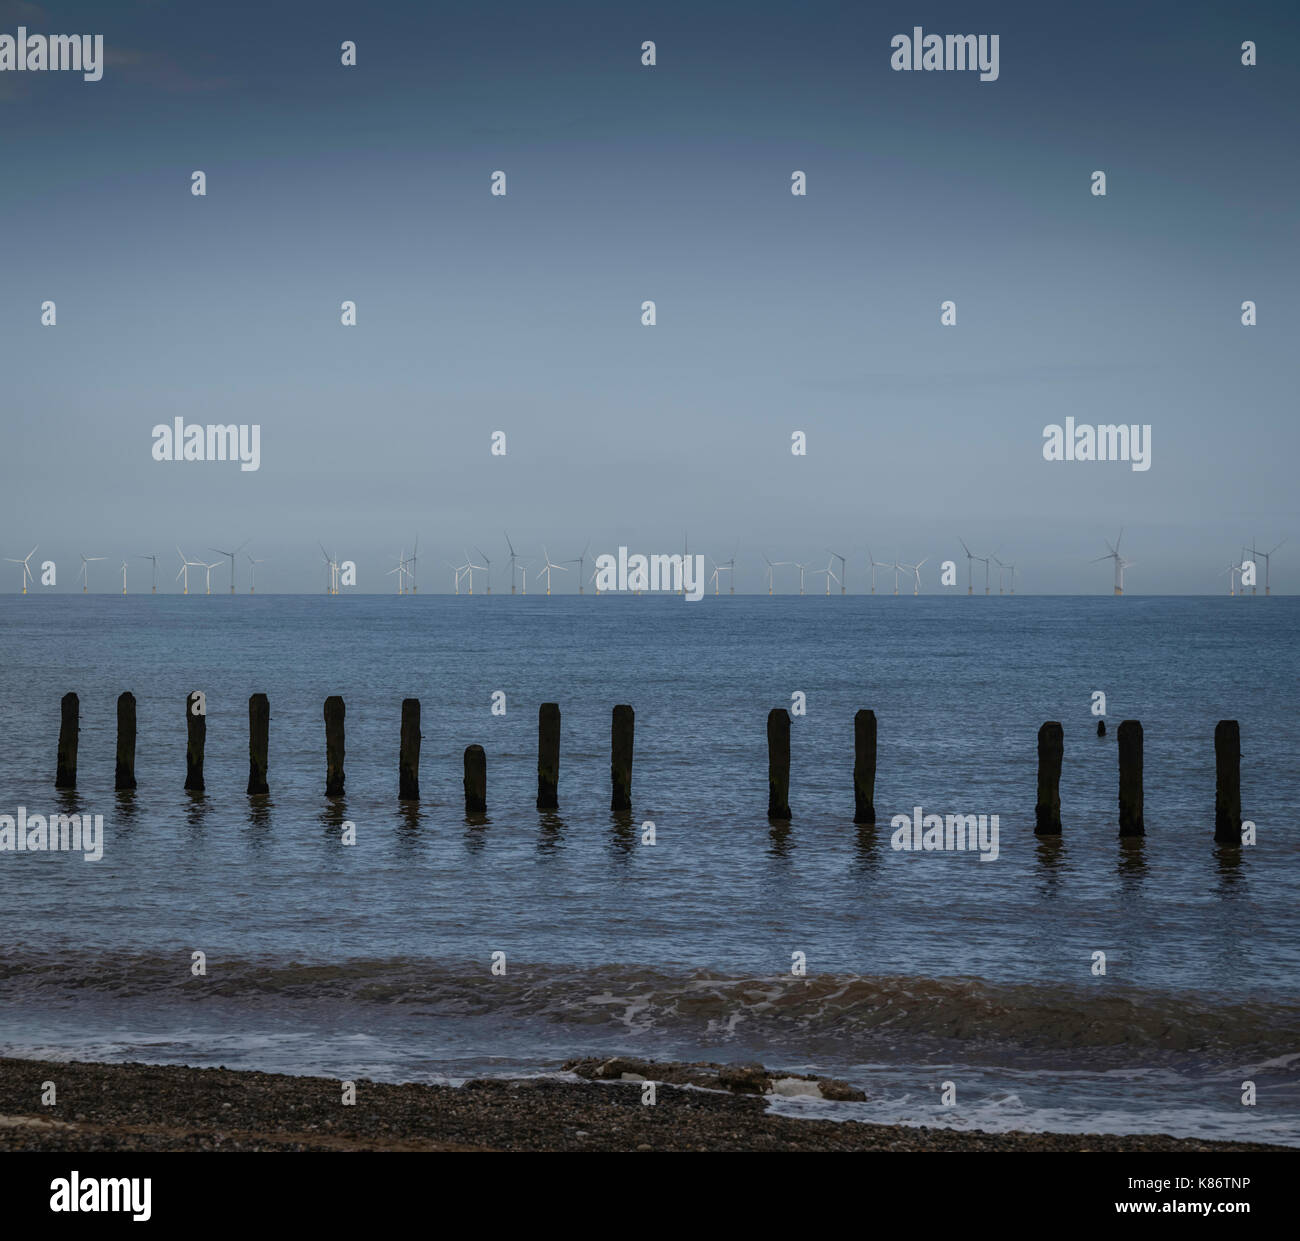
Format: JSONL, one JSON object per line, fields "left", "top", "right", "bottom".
{"left": 0, "top": 0, "right": 1300, "bottom": 594}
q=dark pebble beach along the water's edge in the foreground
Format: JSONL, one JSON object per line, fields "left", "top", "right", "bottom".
{"left": 0, "top": 1058, "right": 1294, "bottom": 1153}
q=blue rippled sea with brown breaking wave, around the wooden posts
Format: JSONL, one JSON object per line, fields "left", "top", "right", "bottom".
{"left": 0, "top": 595, "right": 1300, "bottom": 1145}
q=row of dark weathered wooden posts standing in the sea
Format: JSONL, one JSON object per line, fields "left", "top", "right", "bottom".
{"left": 55, "top": 693, "right": 1242, "bottom": 843}
